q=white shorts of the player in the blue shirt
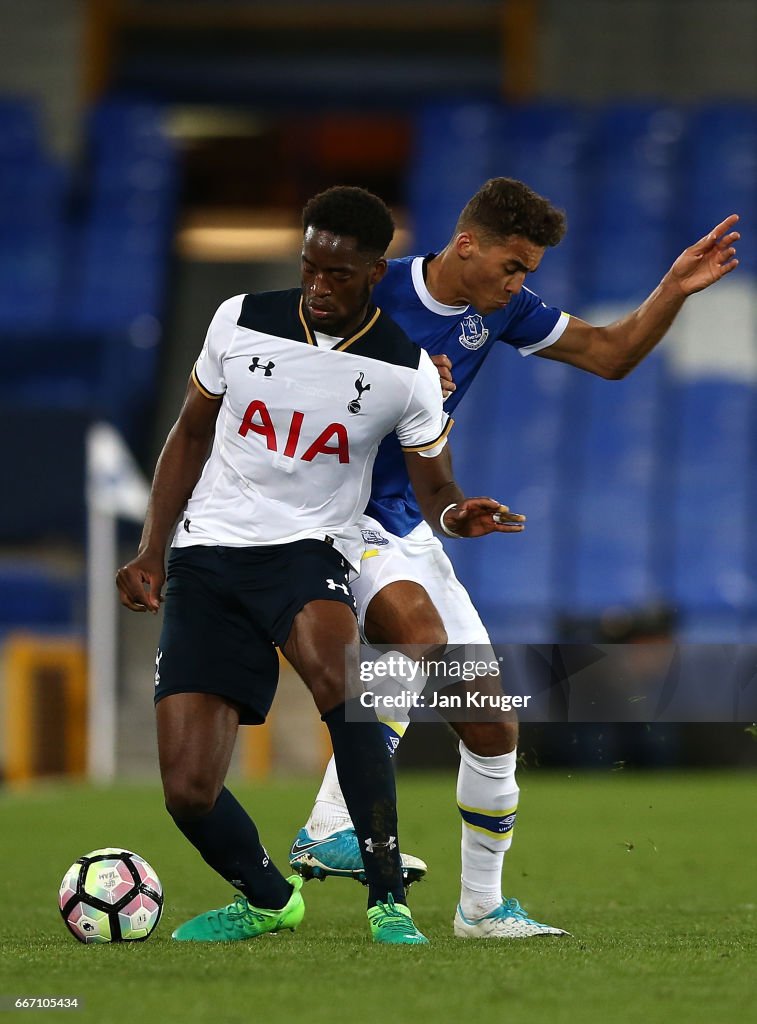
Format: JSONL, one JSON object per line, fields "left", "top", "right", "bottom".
{"left": 350, "top": 515, "right": 491, "bottom": 644}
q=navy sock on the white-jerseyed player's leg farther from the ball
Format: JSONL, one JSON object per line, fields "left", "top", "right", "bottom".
{"left": 322, "top": 701, "right": 406, "bottom": 907}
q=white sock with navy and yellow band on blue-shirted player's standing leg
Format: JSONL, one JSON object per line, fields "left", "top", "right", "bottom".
{"left": 457, "top": 741, "right": 519, "bottom": 919}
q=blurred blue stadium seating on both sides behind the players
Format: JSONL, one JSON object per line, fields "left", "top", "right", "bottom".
{"left": 0, "top": 99, "right": 757, "bottom": 642}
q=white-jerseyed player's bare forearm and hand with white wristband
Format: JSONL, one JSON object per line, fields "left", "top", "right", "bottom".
{"left": 405, "top": 444, "right": 525, "bottom": 537}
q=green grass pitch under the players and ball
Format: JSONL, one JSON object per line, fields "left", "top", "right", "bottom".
{"left": 0, "top": 769, "right": 757, "bottom": 1024}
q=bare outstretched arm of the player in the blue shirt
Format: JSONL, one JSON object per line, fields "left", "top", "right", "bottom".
{"left": 538, "top": 213, "right": 741, "bottom": 380}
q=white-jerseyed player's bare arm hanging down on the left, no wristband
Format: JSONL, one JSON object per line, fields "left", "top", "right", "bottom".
{"left": 116, "top": 379, "right": 220, "bottom": 612}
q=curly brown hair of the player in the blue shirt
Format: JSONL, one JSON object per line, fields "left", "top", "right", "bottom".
{"left": 455, "top": 178, "right": 567, "bottom": 248}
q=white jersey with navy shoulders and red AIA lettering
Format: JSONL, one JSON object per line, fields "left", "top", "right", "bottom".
{"left": 173, "top": 289, "right": 452, "bottom": 565}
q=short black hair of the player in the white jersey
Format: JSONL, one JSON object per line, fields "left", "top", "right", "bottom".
{"left": 302, "top": 185, "right": 394, "bottom": 257}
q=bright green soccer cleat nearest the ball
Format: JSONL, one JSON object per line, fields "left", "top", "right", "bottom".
{"left": 171, "top": 874, "right": 305, "bottom": 942}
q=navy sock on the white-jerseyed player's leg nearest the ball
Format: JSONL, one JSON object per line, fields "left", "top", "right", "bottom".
{"left": 168, "top": 786, "right": 292, "bottom": 910}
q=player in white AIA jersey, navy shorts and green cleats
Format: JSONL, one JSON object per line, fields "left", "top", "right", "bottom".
{"left": 117, "top": 187, "right": 523, "bottom": 944}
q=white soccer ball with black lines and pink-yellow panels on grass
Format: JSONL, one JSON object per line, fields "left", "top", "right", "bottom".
{"left": 57, "top": 847, "right": 163, "bottom": 942}
